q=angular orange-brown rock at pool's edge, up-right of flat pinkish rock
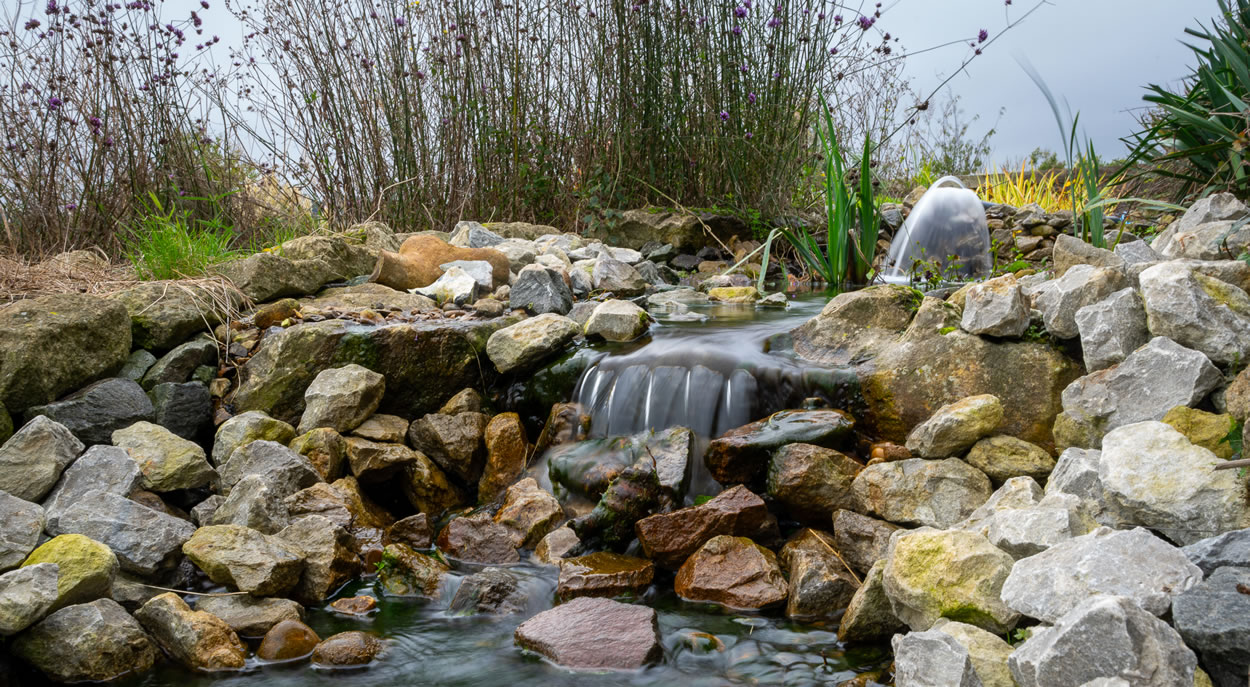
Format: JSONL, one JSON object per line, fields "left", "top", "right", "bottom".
{"left": 674, "top": 535, "right": 788, "bottom": 608}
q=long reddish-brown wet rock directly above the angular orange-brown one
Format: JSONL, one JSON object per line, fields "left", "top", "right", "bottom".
{"left": 634, "top": 485, "right": 769, "bottom": 570}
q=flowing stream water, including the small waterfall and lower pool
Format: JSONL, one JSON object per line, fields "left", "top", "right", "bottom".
{"left": 15, "top": 295, "right": 889, "bottom": 687}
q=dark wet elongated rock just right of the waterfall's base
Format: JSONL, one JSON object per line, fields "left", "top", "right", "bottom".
{"left": 704, "top": 410, "right": 855, "bottom": 485}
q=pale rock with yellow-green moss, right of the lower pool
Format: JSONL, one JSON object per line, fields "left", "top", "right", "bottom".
{"left": 883, "top": 527, "right": 1020, "bottom": 635}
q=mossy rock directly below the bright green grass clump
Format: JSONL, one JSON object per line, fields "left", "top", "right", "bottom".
{"left": 109, "top": 281, "right": 244, "bottom": 351}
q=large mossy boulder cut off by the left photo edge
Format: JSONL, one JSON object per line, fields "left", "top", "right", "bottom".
{"left": 0, "top": 294, "right": 130, "bottom": 413}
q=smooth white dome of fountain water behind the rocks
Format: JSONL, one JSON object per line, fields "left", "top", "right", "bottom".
{"left": 881, "top": 176, "right": 993, "bottom": 284}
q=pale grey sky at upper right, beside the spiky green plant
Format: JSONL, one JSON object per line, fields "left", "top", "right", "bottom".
{"left": 880, "top": 0, "right": 1219, "bottom": 162}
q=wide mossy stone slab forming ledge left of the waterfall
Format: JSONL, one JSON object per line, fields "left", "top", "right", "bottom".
{"left": 235, "top": 316, "right": 519, "bottom": 424}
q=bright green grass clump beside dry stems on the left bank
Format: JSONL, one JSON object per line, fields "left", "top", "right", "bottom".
{"left": 121, "top": 194, "right": 238, "bottom": 280}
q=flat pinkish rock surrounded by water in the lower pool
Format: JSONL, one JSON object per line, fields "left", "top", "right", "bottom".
{"left": 515, "top": 597, "right": 664, "bottom": 671}
